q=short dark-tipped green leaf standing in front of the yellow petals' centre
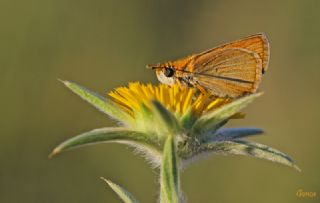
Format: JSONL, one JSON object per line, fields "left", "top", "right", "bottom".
{"left": 152, "top": 100, "right": 181, "bottom": 135}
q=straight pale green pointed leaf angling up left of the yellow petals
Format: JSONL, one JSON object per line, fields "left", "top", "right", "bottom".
{"left": 61, "top": 80, "right": 133, "bottom": 124}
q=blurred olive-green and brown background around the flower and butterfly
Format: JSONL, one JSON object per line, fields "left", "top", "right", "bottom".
{"left": 0, "top": 0, "right": 320, "bottom": 203}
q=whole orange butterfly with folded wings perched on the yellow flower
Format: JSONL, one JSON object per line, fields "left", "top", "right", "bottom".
{"left": 147, "top": 33, "right": 270, "bottom": 97}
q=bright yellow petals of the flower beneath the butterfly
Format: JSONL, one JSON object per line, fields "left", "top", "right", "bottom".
{"left": 109, "top": 82, "right": 231, "bottom": 116}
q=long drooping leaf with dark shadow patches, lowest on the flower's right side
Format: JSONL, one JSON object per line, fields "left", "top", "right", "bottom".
{"left": 199, "top": 140, "right": 300, "bottom": 171}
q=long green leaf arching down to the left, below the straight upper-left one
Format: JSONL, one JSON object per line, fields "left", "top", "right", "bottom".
{"left": 49, "top": 127, "right": 161, "bottom": 157}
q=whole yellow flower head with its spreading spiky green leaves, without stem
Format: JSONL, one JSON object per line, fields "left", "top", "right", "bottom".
{"left": 51, "top": 81, "right": 297, "bottom": 171}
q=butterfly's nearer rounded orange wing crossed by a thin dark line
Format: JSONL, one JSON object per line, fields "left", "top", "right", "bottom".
{"left": 190, "top": 48, "right": 262, "bottom": 97}
